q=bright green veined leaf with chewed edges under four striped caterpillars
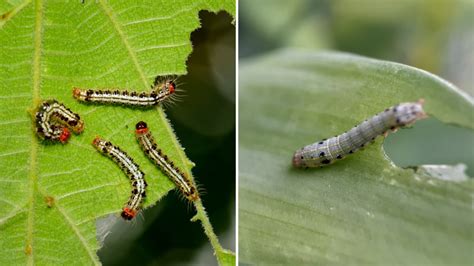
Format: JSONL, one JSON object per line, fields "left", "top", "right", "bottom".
{"left": 0, "top": 0, "right": 235, "bottom": 265}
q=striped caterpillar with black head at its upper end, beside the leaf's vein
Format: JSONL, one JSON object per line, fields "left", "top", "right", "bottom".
{"left": 135, "top": 121, "right": 199, "bottom": 201}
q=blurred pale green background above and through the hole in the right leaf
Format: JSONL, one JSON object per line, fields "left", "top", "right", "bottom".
{"left": 243, "top": 0, "right": 474, "bottom": 177}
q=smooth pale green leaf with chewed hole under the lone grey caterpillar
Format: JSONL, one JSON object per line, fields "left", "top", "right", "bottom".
{"left": 239, "top": 50, "right": 474, "bottom": 265}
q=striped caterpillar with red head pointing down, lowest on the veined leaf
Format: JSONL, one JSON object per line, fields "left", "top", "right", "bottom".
{"left": 92, "top": 137, "right": 148, "bottom": 220}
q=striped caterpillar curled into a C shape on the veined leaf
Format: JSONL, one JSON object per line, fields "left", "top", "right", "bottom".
{"left": 35, "top": 100, "right": 84, "bottom": 143}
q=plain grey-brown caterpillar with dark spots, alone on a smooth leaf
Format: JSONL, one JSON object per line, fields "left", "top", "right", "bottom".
{"left": 292, "top": 99, "right": 427, "bottom": 168}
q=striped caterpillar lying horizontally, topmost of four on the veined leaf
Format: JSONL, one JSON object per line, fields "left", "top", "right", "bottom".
{"left": 72, "top": 77, "right": 176, "bottom": 107}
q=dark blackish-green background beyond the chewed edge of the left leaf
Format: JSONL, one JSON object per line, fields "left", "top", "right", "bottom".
{"left": 98, "top": 11, "right": 236, "bottom": 265}
